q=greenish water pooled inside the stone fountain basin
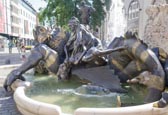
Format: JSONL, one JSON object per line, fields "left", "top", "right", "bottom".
{"left": 26, "top": 75, "right": 145, "bottom": 113}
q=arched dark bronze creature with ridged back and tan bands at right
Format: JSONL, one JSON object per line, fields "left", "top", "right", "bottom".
{"left": 85, "top": 32, "right": 165, "bottom": 102}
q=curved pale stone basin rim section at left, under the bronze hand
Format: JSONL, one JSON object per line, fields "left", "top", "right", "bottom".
{"left": 14, "top": 86, "right": 62, "bottom": 115}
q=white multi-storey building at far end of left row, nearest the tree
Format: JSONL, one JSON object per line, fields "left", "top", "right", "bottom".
{"left": 19, "top": 0, "right": 38, "bottom": 45}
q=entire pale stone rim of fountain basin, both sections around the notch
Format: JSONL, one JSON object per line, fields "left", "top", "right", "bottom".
{"left": 0, "top": 67, "right": 168, "bottom": 115}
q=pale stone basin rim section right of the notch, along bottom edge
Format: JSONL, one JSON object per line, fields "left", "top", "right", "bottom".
{"left": 74, "top": 103, "right": 168, "bottom": 115}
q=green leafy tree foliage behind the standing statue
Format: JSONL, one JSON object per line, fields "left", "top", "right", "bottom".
{"left": 39, "top": 0, "right": 111, "bottom": 28}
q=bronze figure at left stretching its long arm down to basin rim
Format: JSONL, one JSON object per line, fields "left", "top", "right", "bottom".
{"left": 4, "top": 26, "right": 69, "bottom": 91}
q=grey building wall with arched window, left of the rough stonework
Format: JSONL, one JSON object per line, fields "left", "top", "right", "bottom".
{"left": 123, "top": 0, "right": 153, "bottom": 39}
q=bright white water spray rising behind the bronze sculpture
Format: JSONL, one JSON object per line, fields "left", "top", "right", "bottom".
{"left": 107, "top": 0, "right": 126, "bottom": 41}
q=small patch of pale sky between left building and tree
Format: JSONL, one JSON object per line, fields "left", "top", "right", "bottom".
{"left": 27, "top": 0, "right": 47, "bottom": 12}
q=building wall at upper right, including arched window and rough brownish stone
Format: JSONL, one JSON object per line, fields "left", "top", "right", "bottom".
{"left": 124, "top": 0, "right": 168, "bottom": 52}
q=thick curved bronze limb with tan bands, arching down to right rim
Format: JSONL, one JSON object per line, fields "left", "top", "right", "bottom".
{"left": 130, "top": 42, "right": 165, "bottom": 103}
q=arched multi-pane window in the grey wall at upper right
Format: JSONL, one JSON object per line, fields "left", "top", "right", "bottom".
{"left": 128, "top": 0, "right": 140, "bottom": 20}
